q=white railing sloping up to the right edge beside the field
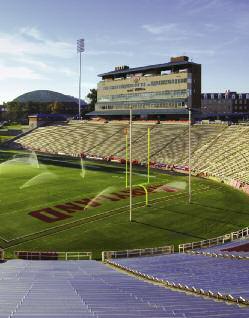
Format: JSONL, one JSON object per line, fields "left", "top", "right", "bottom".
{"left": 178, "top": 227, "right": 249, "bottom": 253}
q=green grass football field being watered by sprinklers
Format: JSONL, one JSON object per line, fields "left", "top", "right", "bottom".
{"left": 0, "top": 153, "right": 249, "bottom": 258}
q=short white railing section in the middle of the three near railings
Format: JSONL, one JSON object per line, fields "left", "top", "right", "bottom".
{"left": 102, "top": 245, "right": 174, "bottom": 262}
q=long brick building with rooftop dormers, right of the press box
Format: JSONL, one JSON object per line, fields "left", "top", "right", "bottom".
{"left": 201, "top": 90, "right": 249, "bottom": 114}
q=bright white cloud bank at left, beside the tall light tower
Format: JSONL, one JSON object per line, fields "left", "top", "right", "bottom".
{"left": 0, "top": 27, "right": 76, "bottom": 80}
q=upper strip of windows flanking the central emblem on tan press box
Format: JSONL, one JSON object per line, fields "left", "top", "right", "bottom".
{"left": 98, "top": 78, "right": 187, "bottom": 90}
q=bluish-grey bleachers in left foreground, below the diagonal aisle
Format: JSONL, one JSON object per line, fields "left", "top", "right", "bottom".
{"left": 0, "top": 260, "right": 249, "bottom": 318}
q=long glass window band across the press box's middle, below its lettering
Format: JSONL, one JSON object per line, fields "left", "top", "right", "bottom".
{"left": 98, "top": 89, "right": 191, "bottom": 102}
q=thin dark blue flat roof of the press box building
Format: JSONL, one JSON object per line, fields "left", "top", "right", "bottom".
{"left": 98, "top": 61, "right": 200, "bottom": 77}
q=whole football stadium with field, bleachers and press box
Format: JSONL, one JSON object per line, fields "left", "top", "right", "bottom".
{"left": 0, "top": 56, "right": 249, "bottom": 318}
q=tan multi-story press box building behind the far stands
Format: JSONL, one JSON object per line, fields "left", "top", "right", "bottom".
{"left": 89, "top": 56, "right": 201, "bottom": 119}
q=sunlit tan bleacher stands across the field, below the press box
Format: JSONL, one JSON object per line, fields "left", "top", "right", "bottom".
{"left": 12, "top": 121, "right": 249, "bottom": 183}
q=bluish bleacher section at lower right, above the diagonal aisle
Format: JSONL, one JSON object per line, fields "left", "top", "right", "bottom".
{"left": 110, "top": 254, "right": 249, "bottom": 301}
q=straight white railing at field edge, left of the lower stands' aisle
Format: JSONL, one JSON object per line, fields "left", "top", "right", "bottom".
{"left": 15, "top": 251, "right": 92, "bottom": 261}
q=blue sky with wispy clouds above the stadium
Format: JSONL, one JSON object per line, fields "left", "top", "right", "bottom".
{"left": 0, "top": 0, "right": 249, "bottom": 103}
